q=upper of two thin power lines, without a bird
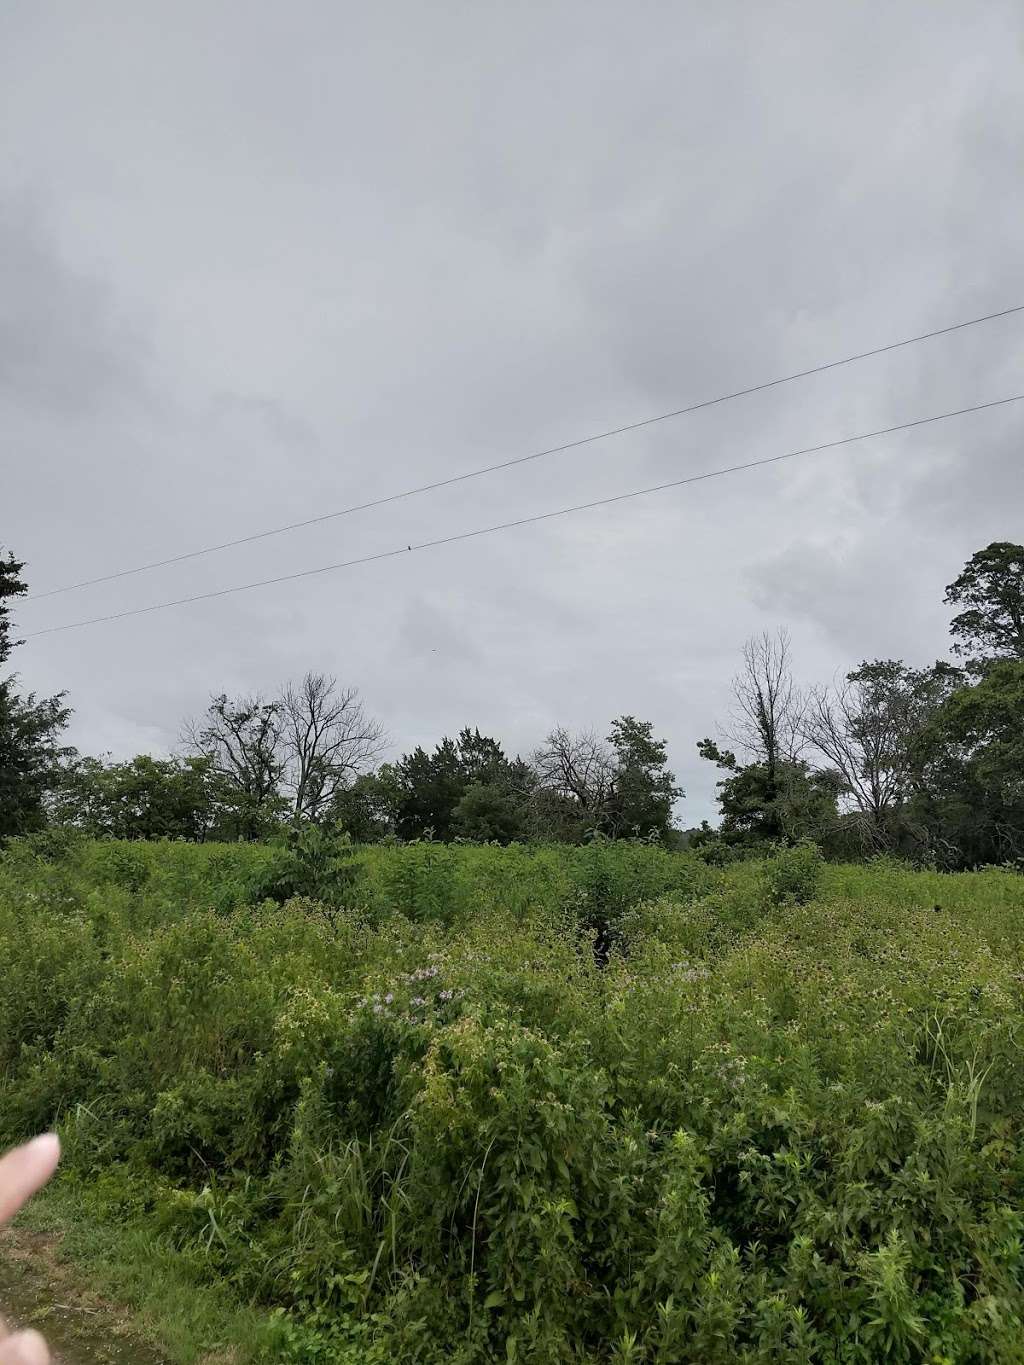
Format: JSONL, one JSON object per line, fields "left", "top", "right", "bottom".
{"left": 25, "top": 303, "right": 1024, "bottom": 602}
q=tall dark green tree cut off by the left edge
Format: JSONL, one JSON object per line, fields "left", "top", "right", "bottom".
{"left": 0, "top": 551, "right": 74, "bottom": 839}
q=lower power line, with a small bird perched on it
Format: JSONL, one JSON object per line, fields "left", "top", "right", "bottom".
{"left": 25, "top": 393, "right": 1024, "bottom": 640}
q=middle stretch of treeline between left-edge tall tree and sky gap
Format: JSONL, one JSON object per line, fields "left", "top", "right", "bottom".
{"left": 54, "top": 704, "right": 681, "bottom": 844}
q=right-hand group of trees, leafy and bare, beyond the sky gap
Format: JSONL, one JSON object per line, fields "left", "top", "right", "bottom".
{"left": 695, "top": 542, "right": 1024, "bottom": 868}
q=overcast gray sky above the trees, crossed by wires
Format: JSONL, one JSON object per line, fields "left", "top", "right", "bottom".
{"left": 0, "top": 0, "right": 1024, "bottom": 824}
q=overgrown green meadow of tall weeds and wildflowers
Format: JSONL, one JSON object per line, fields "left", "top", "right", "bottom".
{"left": 0, "top": 837, "right": 1024, "bottom": 1365}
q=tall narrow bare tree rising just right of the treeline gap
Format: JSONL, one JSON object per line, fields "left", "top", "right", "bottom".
{"left": 724, "top": 628, "right": 806, "bottom": 781}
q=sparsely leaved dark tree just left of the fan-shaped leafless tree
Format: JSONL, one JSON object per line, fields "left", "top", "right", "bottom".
{"left": 183, "top": 692, "right": 283, "bottom": 838}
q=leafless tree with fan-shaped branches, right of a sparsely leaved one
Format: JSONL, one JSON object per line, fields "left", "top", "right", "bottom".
{"left": 277, "top": 673, "right": 386, "bottom": 820}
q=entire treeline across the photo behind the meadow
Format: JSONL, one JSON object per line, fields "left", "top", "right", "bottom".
{"left": 0, "top": 542, "right": 1024, "bottom": 868}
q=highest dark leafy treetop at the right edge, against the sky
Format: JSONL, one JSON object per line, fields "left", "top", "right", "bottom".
{"left": 946, "top": 541, "right": 1024, "bottom": 673}
